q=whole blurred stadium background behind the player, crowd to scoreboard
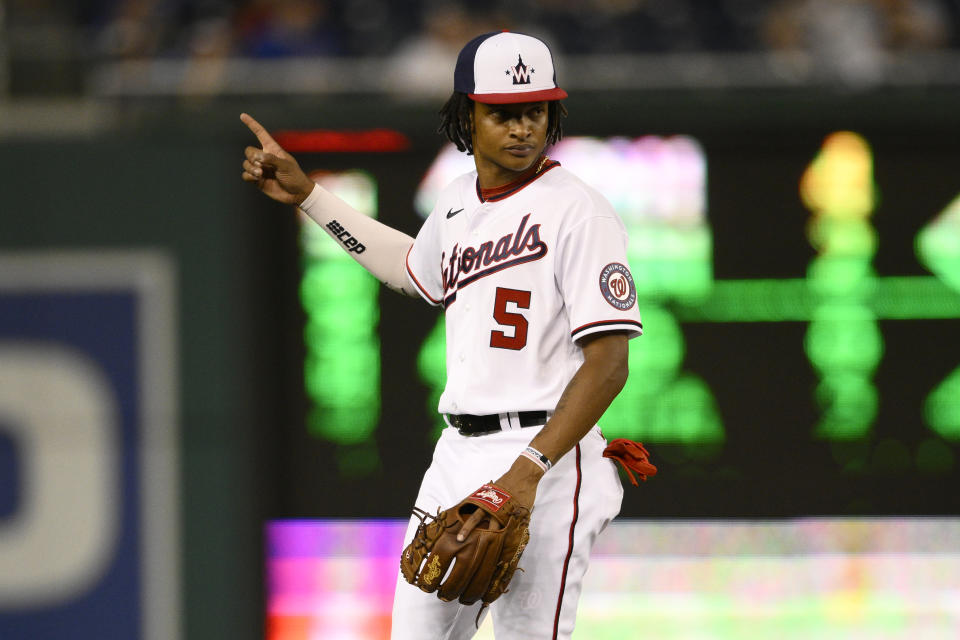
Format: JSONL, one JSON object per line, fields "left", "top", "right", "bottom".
{"left": 0, "top": 0, "right": 960, "bottom": 640}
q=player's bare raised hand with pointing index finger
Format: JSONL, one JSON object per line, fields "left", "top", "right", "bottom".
{"left": 240, "top": 113, "right": 314, "bottom": 205}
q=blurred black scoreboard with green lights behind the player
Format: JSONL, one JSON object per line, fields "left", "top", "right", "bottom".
{"left": 278, "top": 131, "right": 960, "bottom": 517}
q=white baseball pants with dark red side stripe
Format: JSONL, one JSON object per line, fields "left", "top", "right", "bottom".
{"left": 391, "top": 427, "right": 623, "bottom": 640}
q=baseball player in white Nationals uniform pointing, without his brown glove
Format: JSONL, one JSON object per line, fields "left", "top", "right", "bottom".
{"left": 241, "top": 32, "right": 641, "bottom": 640}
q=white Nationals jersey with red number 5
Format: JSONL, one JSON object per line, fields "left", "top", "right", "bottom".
{"left": 407, "top": 158, "right": 642, "bottom": 414}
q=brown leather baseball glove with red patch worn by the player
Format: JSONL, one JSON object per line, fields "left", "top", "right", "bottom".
{"left": 400, "top": 482, "right": 530, "bottom": 621}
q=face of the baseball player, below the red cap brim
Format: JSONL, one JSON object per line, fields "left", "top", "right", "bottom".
{"left": 472, "top": 101, "right": 548, "bottom": 188}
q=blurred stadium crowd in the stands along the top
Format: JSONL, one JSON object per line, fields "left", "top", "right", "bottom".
{"left": 0, "top": 0, "right": 960, "bottom": 93}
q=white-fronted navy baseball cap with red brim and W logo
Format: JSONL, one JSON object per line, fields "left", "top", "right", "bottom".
{"left": 453, "top": 31, "right": 567, "bottom": 104}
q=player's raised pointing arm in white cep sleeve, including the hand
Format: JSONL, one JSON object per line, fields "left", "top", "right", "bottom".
{"left": 240, "top": 113, "right": 419, "bottom": 297}
